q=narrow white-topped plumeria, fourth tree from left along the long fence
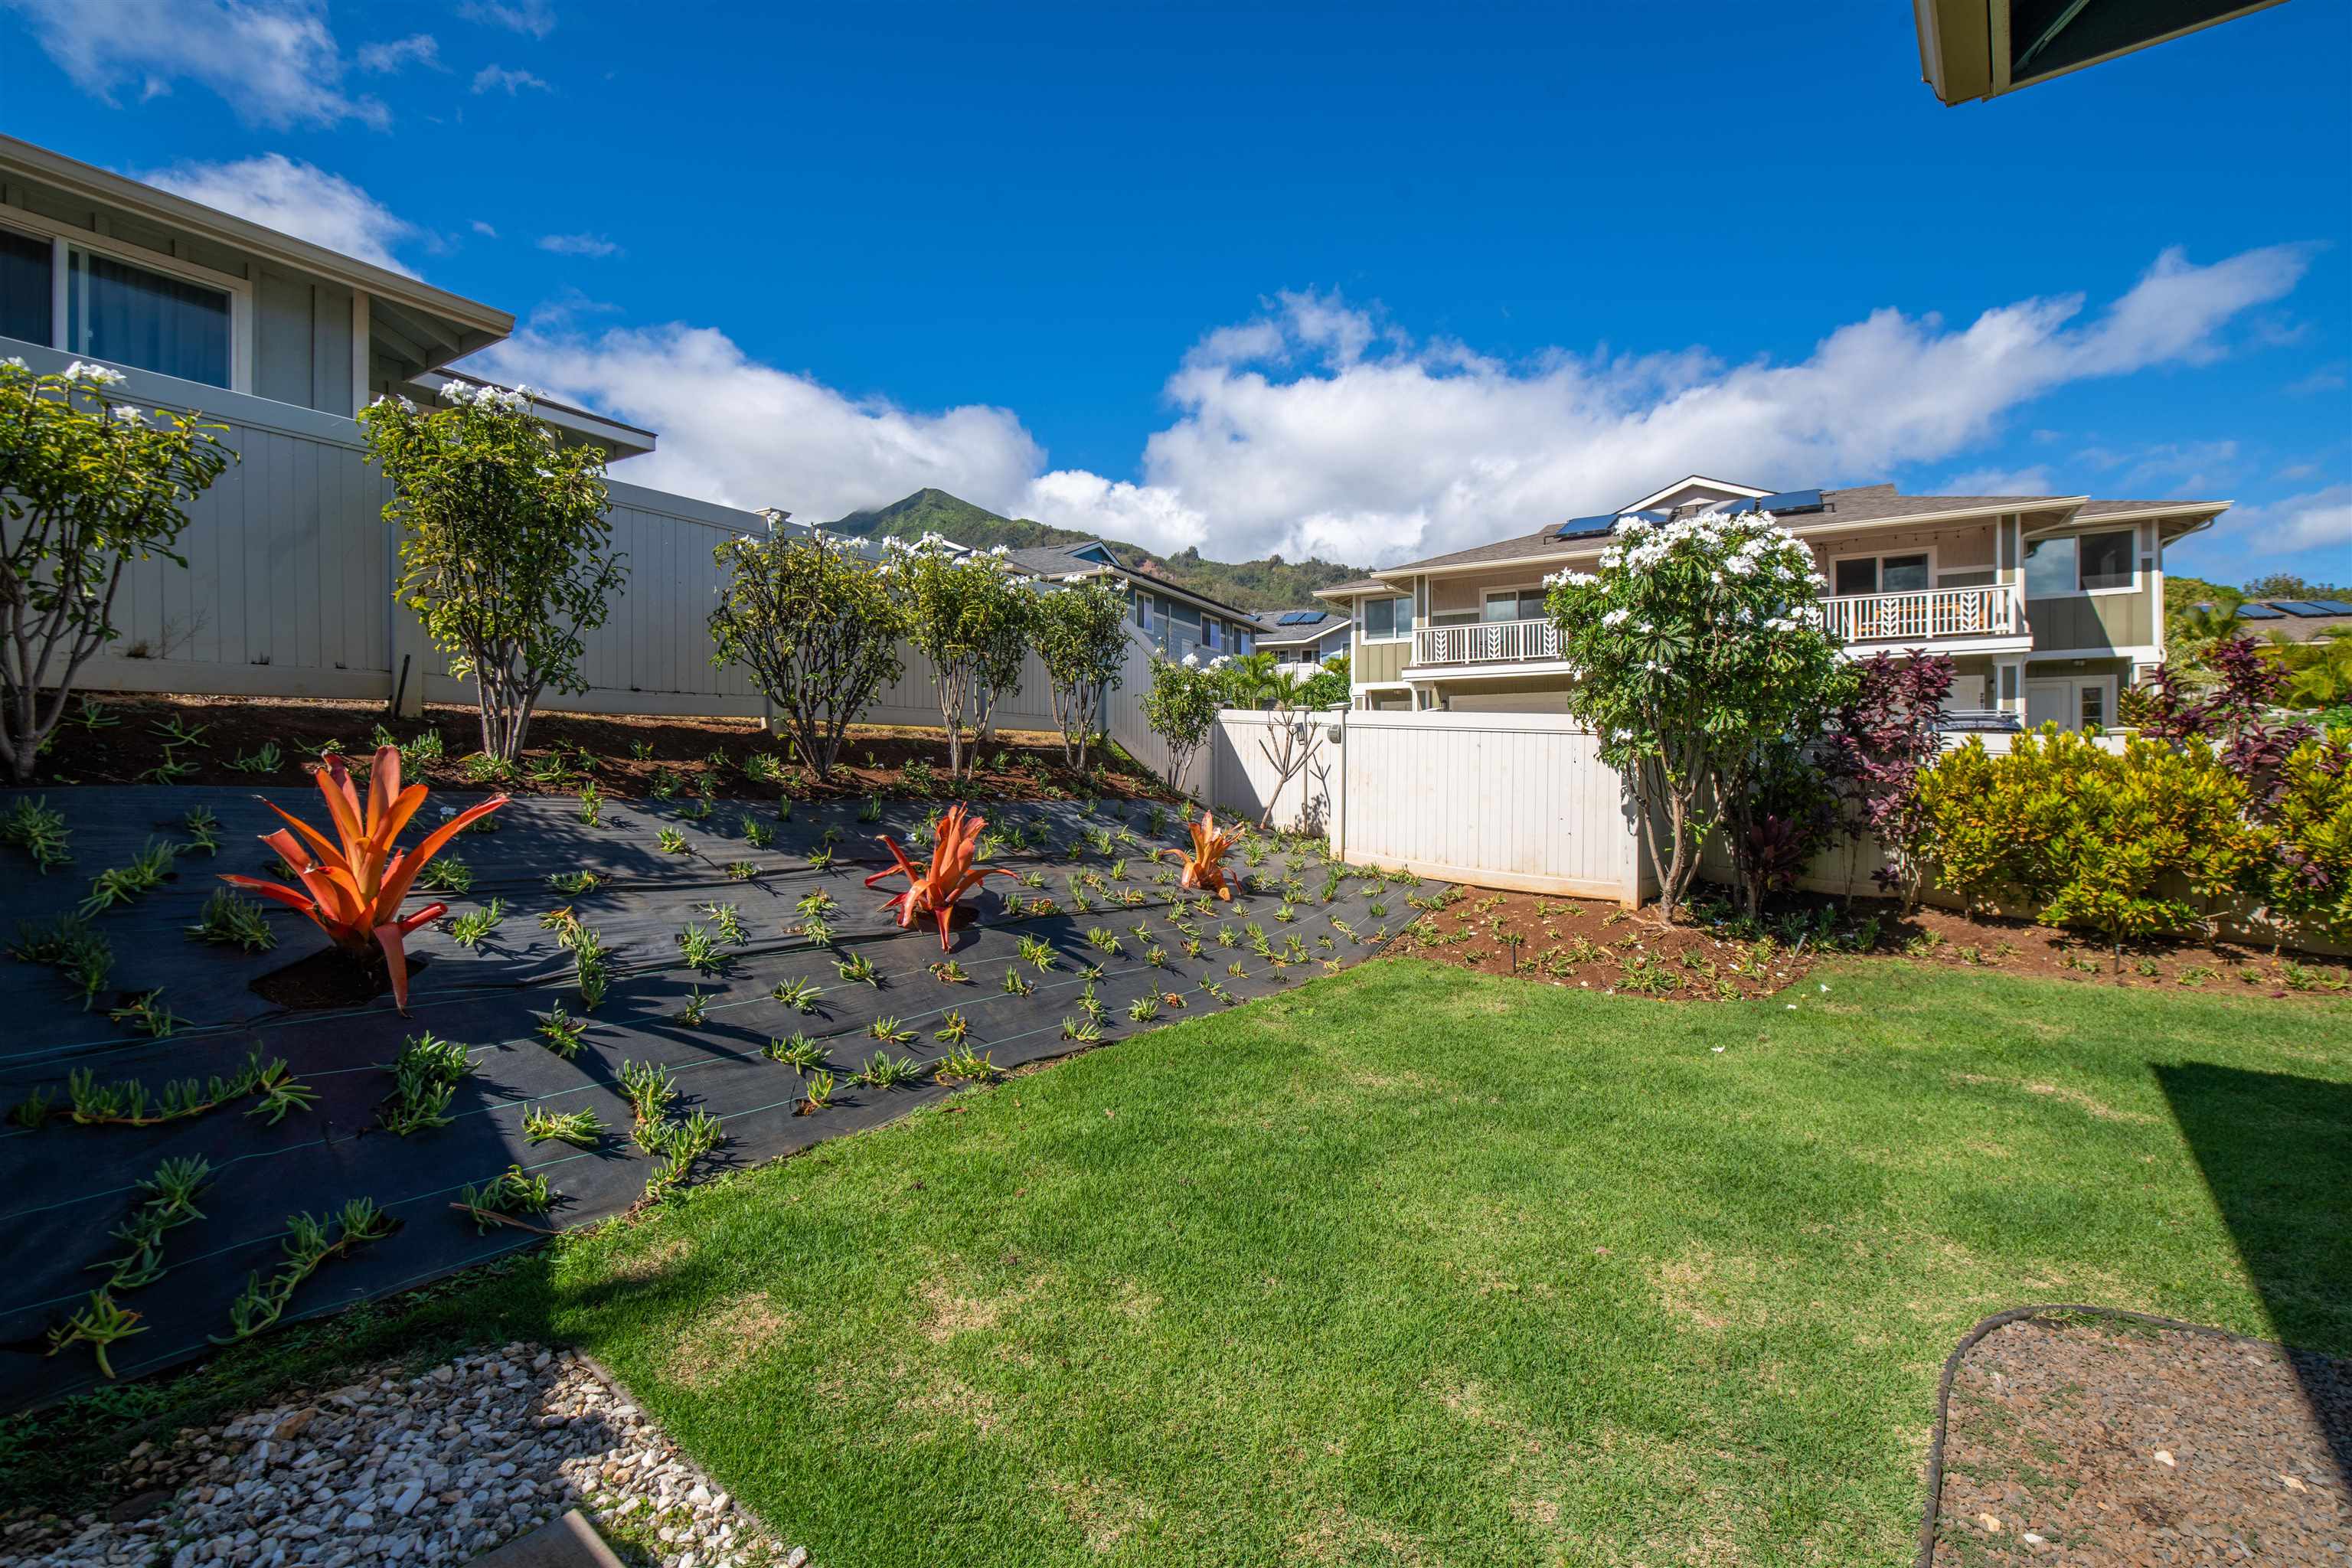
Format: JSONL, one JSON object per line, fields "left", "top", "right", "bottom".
{"left": 882, "top": 534, "right": 1035, "bottom": 778}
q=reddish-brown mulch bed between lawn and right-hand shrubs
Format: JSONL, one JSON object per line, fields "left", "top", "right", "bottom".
{"left": 1390, "top": 887, "right": 2352, "bottom": 1006}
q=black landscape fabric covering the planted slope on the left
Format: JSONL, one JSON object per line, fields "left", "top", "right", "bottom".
{"left": 0, "top": 788, "right": 1435, "bottom": 1410}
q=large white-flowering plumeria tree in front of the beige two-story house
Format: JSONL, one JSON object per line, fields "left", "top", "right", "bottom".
{"left": 1545, "top": 512, "right": 1841, "bottom": 920}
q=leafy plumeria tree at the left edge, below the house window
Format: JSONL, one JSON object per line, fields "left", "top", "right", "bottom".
{"left": 0, "top": 358, "right": 235, "bottom": 782}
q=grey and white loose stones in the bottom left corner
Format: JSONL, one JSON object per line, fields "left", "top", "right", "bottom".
{"left": 0, "top": 1344, "right": 807, "bottom": 1568}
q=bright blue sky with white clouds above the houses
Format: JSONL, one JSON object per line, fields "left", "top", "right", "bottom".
{"left": 0, "top": 0, "right": 2352, "bottom": 580}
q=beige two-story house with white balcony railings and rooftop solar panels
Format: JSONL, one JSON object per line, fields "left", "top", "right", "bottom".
{"left": 1317, "top": 475, "right": 2230, "bottom": 729}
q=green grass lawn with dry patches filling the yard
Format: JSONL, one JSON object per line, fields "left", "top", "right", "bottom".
{"left": 9, "top": 962, "right": 2352, "bottom": 1568}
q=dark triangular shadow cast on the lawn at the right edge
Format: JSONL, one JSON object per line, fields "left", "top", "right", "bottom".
{"left": 2154, "top": 1063, "right": 2352, "bottom": 1486}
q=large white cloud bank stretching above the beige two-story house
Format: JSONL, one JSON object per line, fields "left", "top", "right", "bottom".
{"left": 1086, "top": 247, "right": 2308, "bottom": 564}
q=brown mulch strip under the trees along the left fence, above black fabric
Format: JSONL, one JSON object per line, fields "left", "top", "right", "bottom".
{"left": 11, "top": 696, "right": 1167, "bottom": 799}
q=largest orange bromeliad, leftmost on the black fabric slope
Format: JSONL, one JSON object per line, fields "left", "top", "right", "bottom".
{"left": 221, "top": 745, "right": 505, "bottom": 1013}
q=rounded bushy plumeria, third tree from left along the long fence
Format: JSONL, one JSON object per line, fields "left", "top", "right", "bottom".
{"left": 710, "top": 514, "right": 906, "bottom": 778}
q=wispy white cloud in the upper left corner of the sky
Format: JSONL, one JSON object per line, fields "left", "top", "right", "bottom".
{"left": 0, "top": 0, "right": 393, "bottom": 129}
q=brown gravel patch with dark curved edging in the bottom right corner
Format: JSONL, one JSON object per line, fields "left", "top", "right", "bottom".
{"left": 1933, "top": 1314, "right": 2352, "bottom": 1568}
